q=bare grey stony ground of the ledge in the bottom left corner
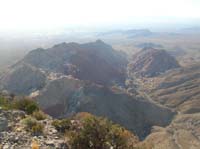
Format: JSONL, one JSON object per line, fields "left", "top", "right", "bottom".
{"left": 0, "top": 110, "right": 68, "bottom": 149}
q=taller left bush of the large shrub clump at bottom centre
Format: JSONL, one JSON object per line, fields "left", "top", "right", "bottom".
{"left": 70, "top": 117, "right": 109, "bottom": 149}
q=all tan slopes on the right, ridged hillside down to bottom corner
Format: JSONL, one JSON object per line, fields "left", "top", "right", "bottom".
{"left": 127, "top": 63, "right": 200, "bottom": 149}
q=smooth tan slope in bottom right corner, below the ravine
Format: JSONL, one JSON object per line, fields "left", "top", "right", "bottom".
{"left": 144, "top": 113, "right": 200, "bottom": 149}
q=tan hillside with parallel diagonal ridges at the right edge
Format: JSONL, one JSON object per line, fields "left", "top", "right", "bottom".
{"left": 147, "top": 64, "right": 200, "bottom": 113}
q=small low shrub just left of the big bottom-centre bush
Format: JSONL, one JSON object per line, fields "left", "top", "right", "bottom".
{"left": 52, "top": 119, "right": 71, "bottom": 133}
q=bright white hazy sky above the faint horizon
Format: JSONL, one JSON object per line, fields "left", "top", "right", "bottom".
{"left": 0, "top": 0, "right": 200, "bottom": 31}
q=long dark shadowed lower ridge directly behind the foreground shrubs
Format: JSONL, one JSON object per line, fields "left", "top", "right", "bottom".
{"left": 36, "top": 77, "right": 175, "bottom": 138}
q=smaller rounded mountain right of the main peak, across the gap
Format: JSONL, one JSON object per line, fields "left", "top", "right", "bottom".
{"left": 128, "top": 48, "right": 180, "bottom": 77}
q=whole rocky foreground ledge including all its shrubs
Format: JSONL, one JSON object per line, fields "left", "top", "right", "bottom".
{"left": 0, "top": 109, "right": 143, "bottom": 149}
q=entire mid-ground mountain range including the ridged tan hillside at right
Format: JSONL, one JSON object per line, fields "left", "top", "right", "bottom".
{"left": 0, "top": 40, "right": 199, "bottom": 148}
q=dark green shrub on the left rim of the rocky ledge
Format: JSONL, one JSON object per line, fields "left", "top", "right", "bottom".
{"left": 13, "top": 98, "right": 39, "bottom": 114}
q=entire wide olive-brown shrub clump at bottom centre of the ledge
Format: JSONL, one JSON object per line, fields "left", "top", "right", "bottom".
{"left": 70, "top": 116, "right": 137, "bottom": 149}
